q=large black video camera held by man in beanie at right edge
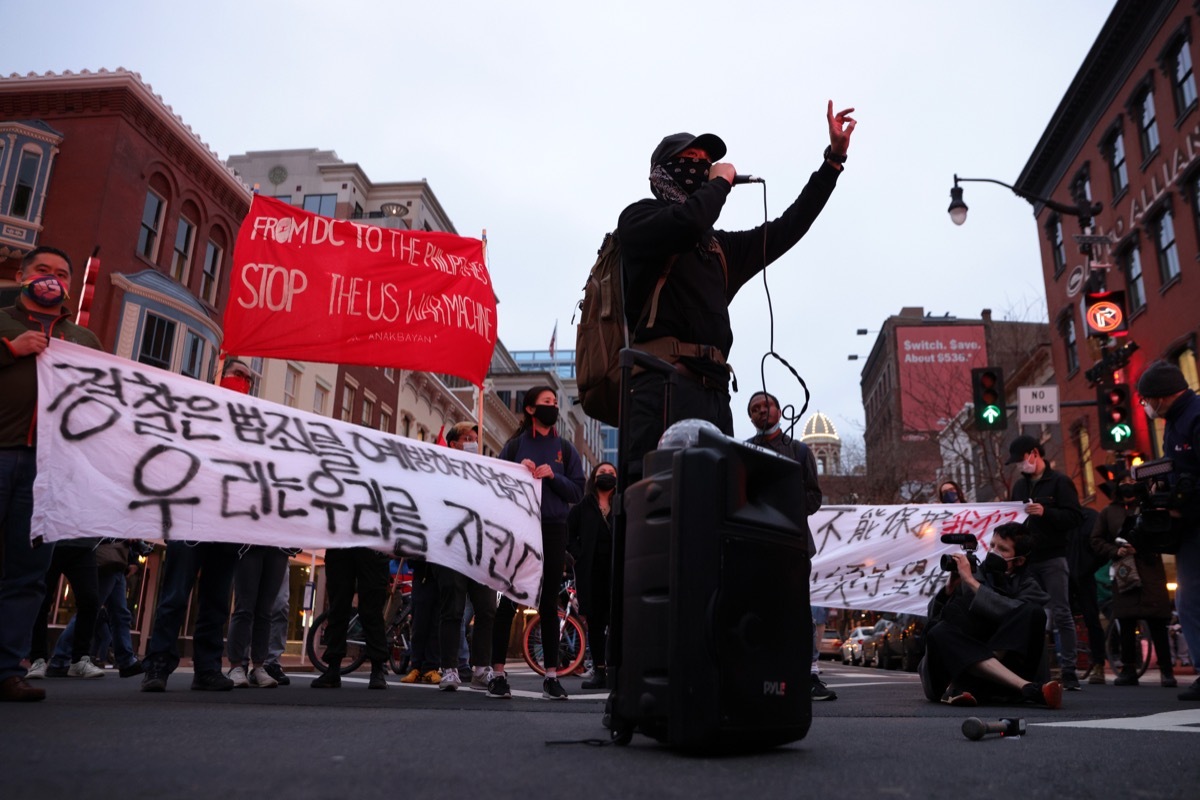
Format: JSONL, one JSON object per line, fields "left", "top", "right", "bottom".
{"left": 1117, "top": 458, "right": 1198, "bottom": 553}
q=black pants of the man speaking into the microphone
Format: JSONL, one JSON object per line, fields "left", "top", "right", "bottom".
{"left": 620, "top": 372, "right": 733, "bottom": 477}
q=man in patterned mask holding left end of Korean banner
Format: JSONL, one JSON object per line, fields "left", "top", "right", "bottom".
{"left": 0, "top": 246, "right": 102, "bottom": 700}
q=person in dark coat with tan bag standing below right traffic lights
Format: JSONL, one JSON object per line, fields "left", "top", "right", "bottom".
{"left": 1092, "top": 464, "right": 1176, "bottom": 688}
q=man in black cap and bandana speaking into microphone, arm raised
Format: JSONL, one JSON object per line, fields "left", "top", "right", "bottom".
{"left": 617, "top": 101, "right": 856, "bottom": 469}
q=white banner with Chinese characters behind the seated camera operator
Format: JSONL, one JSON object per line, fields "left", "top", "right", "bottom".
{"left": 809, "top": 503, "right": 1025, "bottom": 614}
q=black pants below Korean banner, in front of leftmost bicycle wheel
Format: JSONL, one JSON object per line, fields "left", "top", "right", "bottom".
{"left": 324, "top": 547, "right": 391, "bottom": 664}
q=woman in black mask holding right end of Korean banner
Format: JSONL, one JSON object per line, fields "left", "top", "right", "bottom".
{"left": 487, "top": 386, "right": 583, "bottom": 700}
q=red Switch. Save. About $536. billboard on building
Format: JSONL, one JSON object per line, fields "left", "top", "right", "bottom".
{"left": 895, "top": 325, "right": 988, "bottom": 439}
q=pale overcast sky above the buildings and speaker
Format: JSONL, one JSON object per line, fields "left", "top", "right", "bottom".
{"left": 7, "top": 0, "right": 1112, "bottom": 438}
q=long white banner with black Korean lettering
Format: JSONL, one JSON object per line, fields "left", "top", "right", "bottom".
{"left": 32, "top": 341, "right": 542, "bottom": 603}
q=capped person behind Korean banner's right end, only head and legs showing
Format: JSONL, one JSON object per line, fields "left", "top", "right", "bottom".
{"left": 437, "top": 422, "right": 496, "bottom": 692}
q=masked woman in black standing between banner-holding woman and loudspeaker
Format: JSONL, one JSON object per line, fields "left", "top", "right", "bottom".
{"left": 566, "top": 461, "right": 617, "bottom": 688}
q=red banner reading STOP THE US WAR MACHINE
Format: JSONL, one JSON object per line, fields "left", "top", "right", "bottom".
{"left": 222, "top": 194, "right": 496, "bottom": 385}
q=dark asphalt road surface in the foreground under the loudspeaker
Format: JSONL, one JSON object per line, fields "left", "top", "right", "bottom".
{"left": 0, "top": 664, "right": 1200, "bottom": 800}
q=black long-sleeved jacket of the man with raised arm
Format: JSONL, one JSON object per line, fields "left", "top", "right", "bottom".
{"left": 617, "top": 162, "right": 839, "bottom": 357}
